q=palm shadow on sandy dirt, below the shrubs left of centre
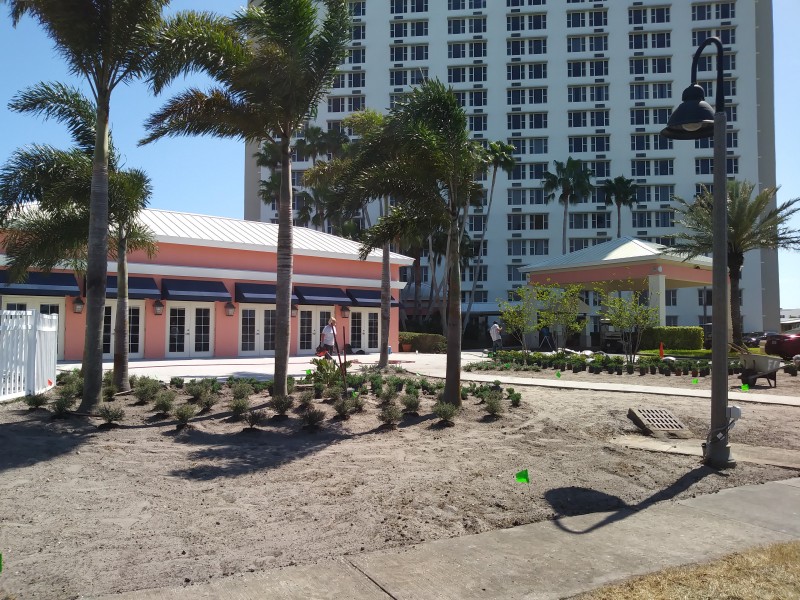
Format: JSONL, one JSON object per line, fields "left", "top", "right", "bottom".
{"left": 164, "top": 419, "right": 352, "bottom": 481}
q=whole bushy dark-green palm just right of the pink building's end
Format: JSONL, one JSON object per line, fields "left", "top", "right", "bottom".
{"left": 351, "top": 80, "right": 483, "bottom": 405}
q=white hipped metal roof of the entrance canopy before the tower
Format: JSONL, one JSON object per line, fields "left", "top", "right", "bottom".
{"left": 519, "top": 237, "right": 711, "bottom": 273}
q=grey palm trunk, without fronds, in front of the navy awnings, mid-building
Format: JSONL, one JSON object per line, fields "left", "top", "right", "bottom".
{"left": 274, "top": 136, "right": 293, "bottom": 396}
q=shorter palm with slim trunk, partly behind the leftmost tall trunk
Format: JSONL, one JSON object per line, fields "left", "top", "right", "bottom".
{"left": 0, "top": 83, "right": 155, "bottom": 391}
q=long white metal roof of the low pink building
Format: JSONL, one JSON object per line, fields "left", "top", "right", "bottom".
{"left": 139, "top": 208, "right": 414, "bottom": 265}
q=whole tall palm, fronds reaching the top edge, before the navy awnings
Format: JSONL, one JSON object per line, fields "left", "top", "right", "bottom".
{"left": 141, "top": 0, "right": 350, "bottom": 394}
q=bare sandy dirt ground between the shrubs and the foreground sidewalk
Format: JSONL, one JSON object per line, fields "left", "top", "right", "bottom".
{"left": 0, "top": 371, "right": 800, "bottom": 600}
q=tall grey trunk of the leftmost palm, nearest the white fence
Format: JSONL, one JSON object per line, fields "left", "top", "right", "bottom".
{"left": 78, "top": 98, "right": 111, "bottom": 413}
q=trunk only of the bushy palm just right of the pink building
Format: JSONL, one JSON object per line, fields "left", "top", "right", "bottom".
{"left": 443, "top": 215, "right": 461, "bottom": 406}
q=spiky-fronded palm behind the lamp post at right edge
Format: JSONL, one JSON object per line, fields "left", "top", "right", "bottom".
{"left": 672, "top": 181, "right": 800, "bottom": 345}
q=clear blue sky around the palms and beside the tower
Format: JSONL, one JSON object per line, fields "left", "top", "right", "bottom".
{"left": 0, "top": 0, "right": 800, "bottom": 308}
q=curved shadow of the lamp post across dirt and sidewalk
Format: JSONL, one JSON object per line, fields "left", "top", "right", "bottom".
{"left": 544, "top": 466, "right": 727, "bottom": 534}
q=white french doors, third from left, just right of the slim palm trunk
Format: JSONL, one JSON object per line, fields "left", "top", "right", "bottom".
{"left": 166, "top": 302, "right": 214, "bottom": 358}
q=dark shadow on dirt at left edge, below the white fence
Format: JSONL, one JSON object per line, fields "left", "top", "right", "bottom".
{"left": 0, "top": 409, "right": 97, "bottom": 473}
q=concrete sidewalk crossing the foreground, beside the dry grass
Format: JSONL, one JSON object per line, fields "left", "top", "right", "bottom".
{"left": 95, "top": 478, "right": 800, "bottom": 600}
